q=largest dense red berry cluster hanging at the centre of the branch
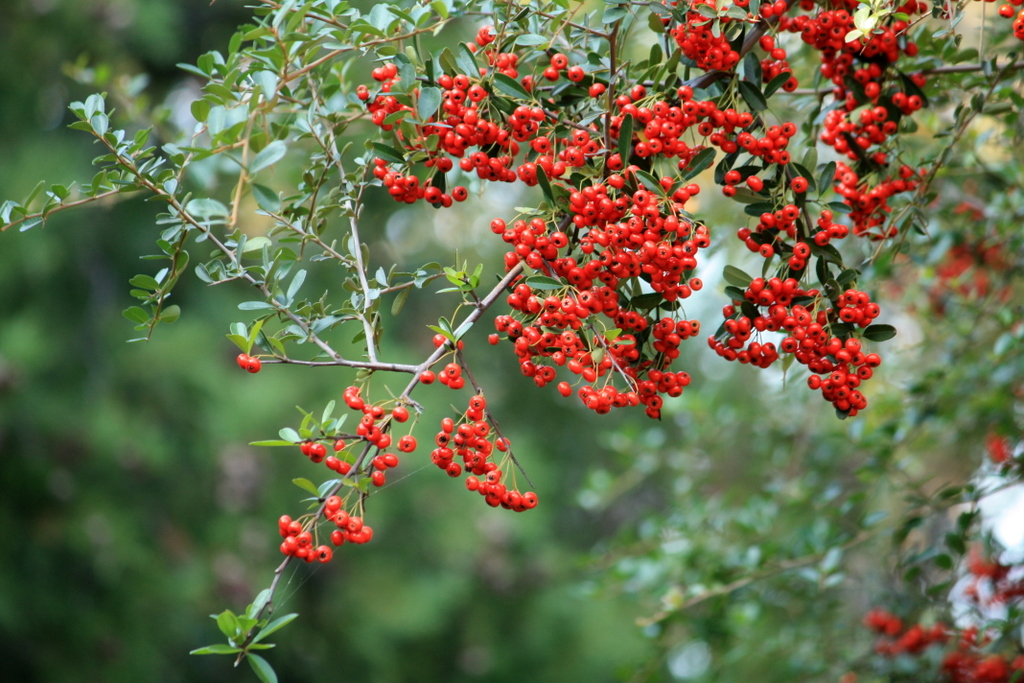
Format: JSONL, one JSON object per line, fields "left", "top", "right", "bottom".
{"left": 492, "top": 174, "right": 711, "bottom": 418}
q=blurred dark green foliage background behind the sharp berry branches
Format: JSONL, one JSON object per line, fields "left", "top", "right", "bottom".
{"left": 0, "top": 0, "right": 1021, "bottom": 683}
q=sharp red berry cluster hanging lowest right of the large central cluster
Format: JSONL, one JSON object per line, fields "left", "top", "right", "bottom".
{"left": 708, "top": 278, "right": 882, "bottom": 416}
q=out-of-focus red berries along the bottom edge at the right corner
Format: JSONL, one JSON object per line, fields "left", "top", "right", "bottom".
{"left": 864, "top": 608, "right": 1024, "bottom": 683}
